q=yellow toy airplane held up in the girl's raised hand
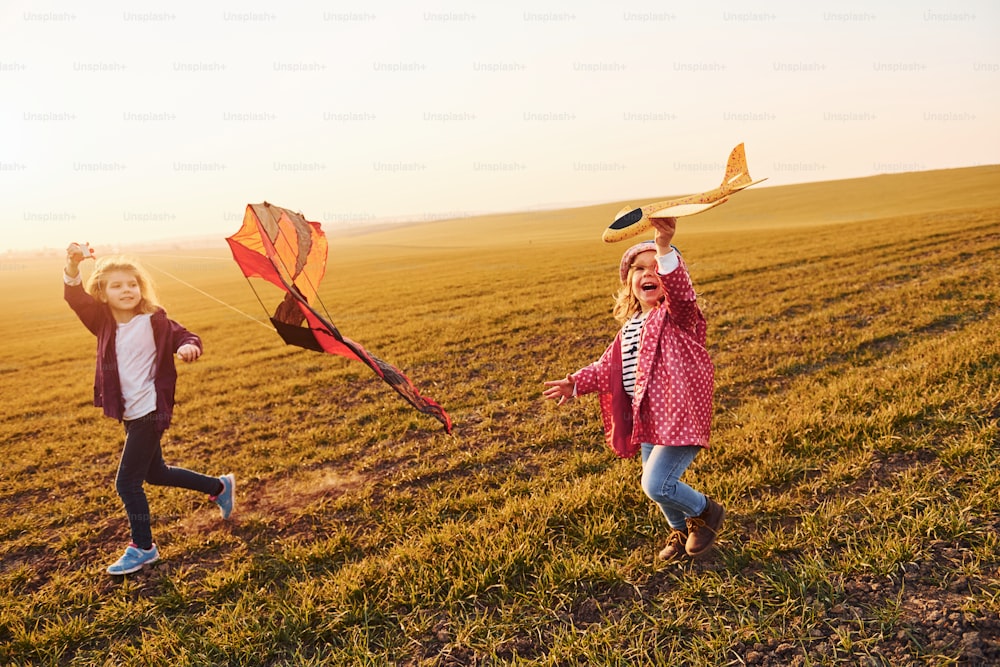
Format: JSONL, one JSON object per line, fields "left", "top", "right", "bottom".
{"left": 601, "top": 144, "right": 767, "bottom": 243}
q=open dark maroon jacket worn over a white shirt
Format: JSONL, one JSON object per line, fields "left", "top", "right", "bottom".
{"left": 64, "top": 285, "right": 202, "bottom": 430}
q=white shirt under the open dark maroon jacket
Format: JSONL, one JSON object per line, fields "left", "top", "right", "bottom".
{"left": 115, "top": 313, "right": 156, "bottom": 420}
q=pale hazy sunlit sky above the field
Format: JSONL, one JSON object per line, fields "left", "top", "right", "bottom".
{"left": 0, "top": 0, "right": 1000, "bottom": 252}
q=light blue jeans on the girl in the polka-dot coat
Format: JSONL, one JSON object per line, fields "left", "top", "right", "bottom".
{"left": 642, "top": 442, "right": 708, "bottom": 531}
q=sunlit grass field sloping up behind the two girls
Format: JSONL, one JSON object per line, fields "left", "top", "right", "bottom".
{"left": 0, "top": 167, "right": 1000, "bottom": 666}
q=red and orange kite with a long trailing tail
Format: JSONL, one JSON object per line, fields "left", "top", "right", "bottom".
{"left": 226, "top": 202, "right": 451, "bottom": 433}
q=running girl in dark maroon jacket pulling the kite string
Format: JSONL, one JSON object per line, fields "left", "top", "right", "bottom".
{"left": 63, "top": 243, "right": 236, "bottom": 575}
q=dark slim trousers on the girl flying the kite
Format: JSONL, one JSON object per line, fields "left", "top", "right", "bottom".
{"left": 115, "top": 412, "right": 219, "bottom": 549}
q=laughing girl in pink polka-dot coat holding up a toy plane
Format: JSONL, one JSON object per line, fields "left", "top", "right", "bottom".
{"left": 543, "top": 218, "right": 726, "bottom": 560}
